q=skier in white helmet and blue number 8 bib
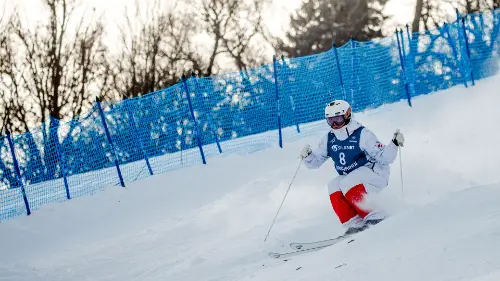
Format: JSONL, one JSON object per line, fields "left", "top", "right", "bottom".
{"left": 300, "top": 100, "right": 404, "bottom": 234}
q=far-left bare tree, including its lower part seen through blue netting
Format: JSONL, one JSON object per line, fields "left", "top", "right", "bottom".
{"left": 1, "top": 0, "right": 109, "bottom": 178}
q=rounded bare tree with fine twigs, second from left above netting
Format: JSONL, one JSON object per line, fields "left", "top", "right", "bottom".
{"left": 113, "top": 1, "right": 199, "bottom": 97}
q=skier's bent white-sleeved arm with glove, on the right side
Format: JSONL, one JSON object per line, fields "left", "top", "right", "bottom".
{"left": 360, "top": 128, "right": 404, "bottom": 164}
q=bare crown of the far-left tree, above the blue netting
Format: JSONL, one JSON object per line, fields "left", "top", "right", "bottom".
{"left": 7, "top": 0, "right": 109, "bottom": 127}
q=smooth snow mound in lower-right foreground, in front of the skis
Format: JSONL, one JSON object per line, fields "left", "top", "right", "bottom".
{"left": 252, "top": 184, "right": 500, "bottom": 281}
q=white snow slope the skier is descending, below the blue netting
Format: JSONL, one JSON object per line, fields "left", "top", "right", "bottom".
{"left": 0, "top": 74, "right": 500, "bottom": 281}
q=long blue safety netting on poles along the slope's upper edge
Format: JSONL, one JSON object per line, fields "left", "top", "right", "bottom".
{"left": 0, "top": 10, "right": 500, "bottom": 221}
